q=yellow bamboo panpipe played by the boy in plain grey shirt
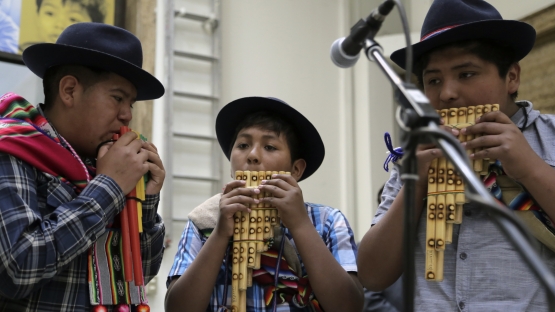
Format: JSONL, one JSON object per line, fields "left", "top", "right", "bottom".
{"left": 425, "top": 104, "right": 499, "bottom": 282}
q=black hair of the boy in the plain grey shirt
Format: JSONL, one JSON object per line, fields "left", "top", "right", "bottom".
{"left": 414, "top": 39, "right": 518, "bottom": 101}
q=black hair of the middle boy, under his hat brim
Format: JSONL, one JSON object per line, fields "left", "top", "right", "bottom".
{"left": 228, "top": 111, "right": 302, "bottom": 162}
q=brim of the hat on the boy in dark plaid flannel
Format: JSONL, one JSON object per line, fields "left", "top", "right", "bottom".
{"left": 23, "top": 43, "right": 164, "bottom": 101}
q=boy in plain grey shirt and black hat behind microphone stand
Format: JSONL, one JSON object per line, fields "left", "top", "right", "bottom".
{"left": 357, "top": 0, "right": 555, "bottom": 311}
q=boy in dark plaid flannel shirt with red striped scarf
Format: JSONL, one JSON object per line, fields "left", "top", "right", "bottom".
{"left": 0, "top": 23, "right": 165, "bottom": 311}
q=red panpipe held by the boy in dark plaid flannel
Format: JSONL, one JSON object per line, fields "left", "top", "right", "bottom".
{"left": 113, "top": 126, "right": 146, "bottom": 286}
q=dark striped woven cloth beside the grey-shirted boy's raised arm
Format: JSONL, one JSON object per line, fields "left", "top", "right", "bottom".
{"left": 483, "top": 160, "right": 555, "bottom": 234}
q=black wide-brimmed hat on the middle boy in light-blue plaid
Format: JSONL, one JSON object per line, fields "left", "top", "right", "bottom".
{"left": 216, "top": 96, "right": 325, "bottom": 181}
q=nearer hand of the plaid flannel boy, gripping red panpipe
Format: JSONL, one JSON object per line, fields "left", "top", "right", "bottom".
{"left": 96, "top": 132, "right": 149, "bottom": 195}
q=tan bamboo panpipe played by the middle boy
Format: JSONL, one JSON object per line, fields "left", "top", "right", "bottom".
{"left": 231, "top": 171, "right": 291, "bottom": 312}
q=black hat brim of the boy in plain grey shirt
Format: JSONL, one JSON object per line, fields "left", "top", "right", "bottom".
{"left": 391, "top": 20, "right": 536, "bottom": 69}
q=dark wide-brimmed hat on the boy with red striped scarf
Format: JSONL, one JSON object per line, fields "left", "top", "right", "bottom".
{"left": 23, "top": 23, "right": 164, "bottom": 101}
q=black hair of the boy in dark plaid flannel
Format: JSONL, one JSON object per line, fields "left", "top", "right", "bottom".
{"left": 42, "top": 65, "right": 111, "bottom": 109}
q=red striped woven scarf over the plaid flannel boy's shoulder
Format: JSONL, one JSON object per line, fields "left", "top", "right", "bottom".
{"left": 0, "top": 93, "right": 90, "bottom": 194}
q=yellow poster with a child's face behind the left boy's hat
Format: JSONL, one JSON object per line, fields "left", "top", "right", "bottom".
{"left": 0, "top": 0, "right": 123, "bottom": 63}
